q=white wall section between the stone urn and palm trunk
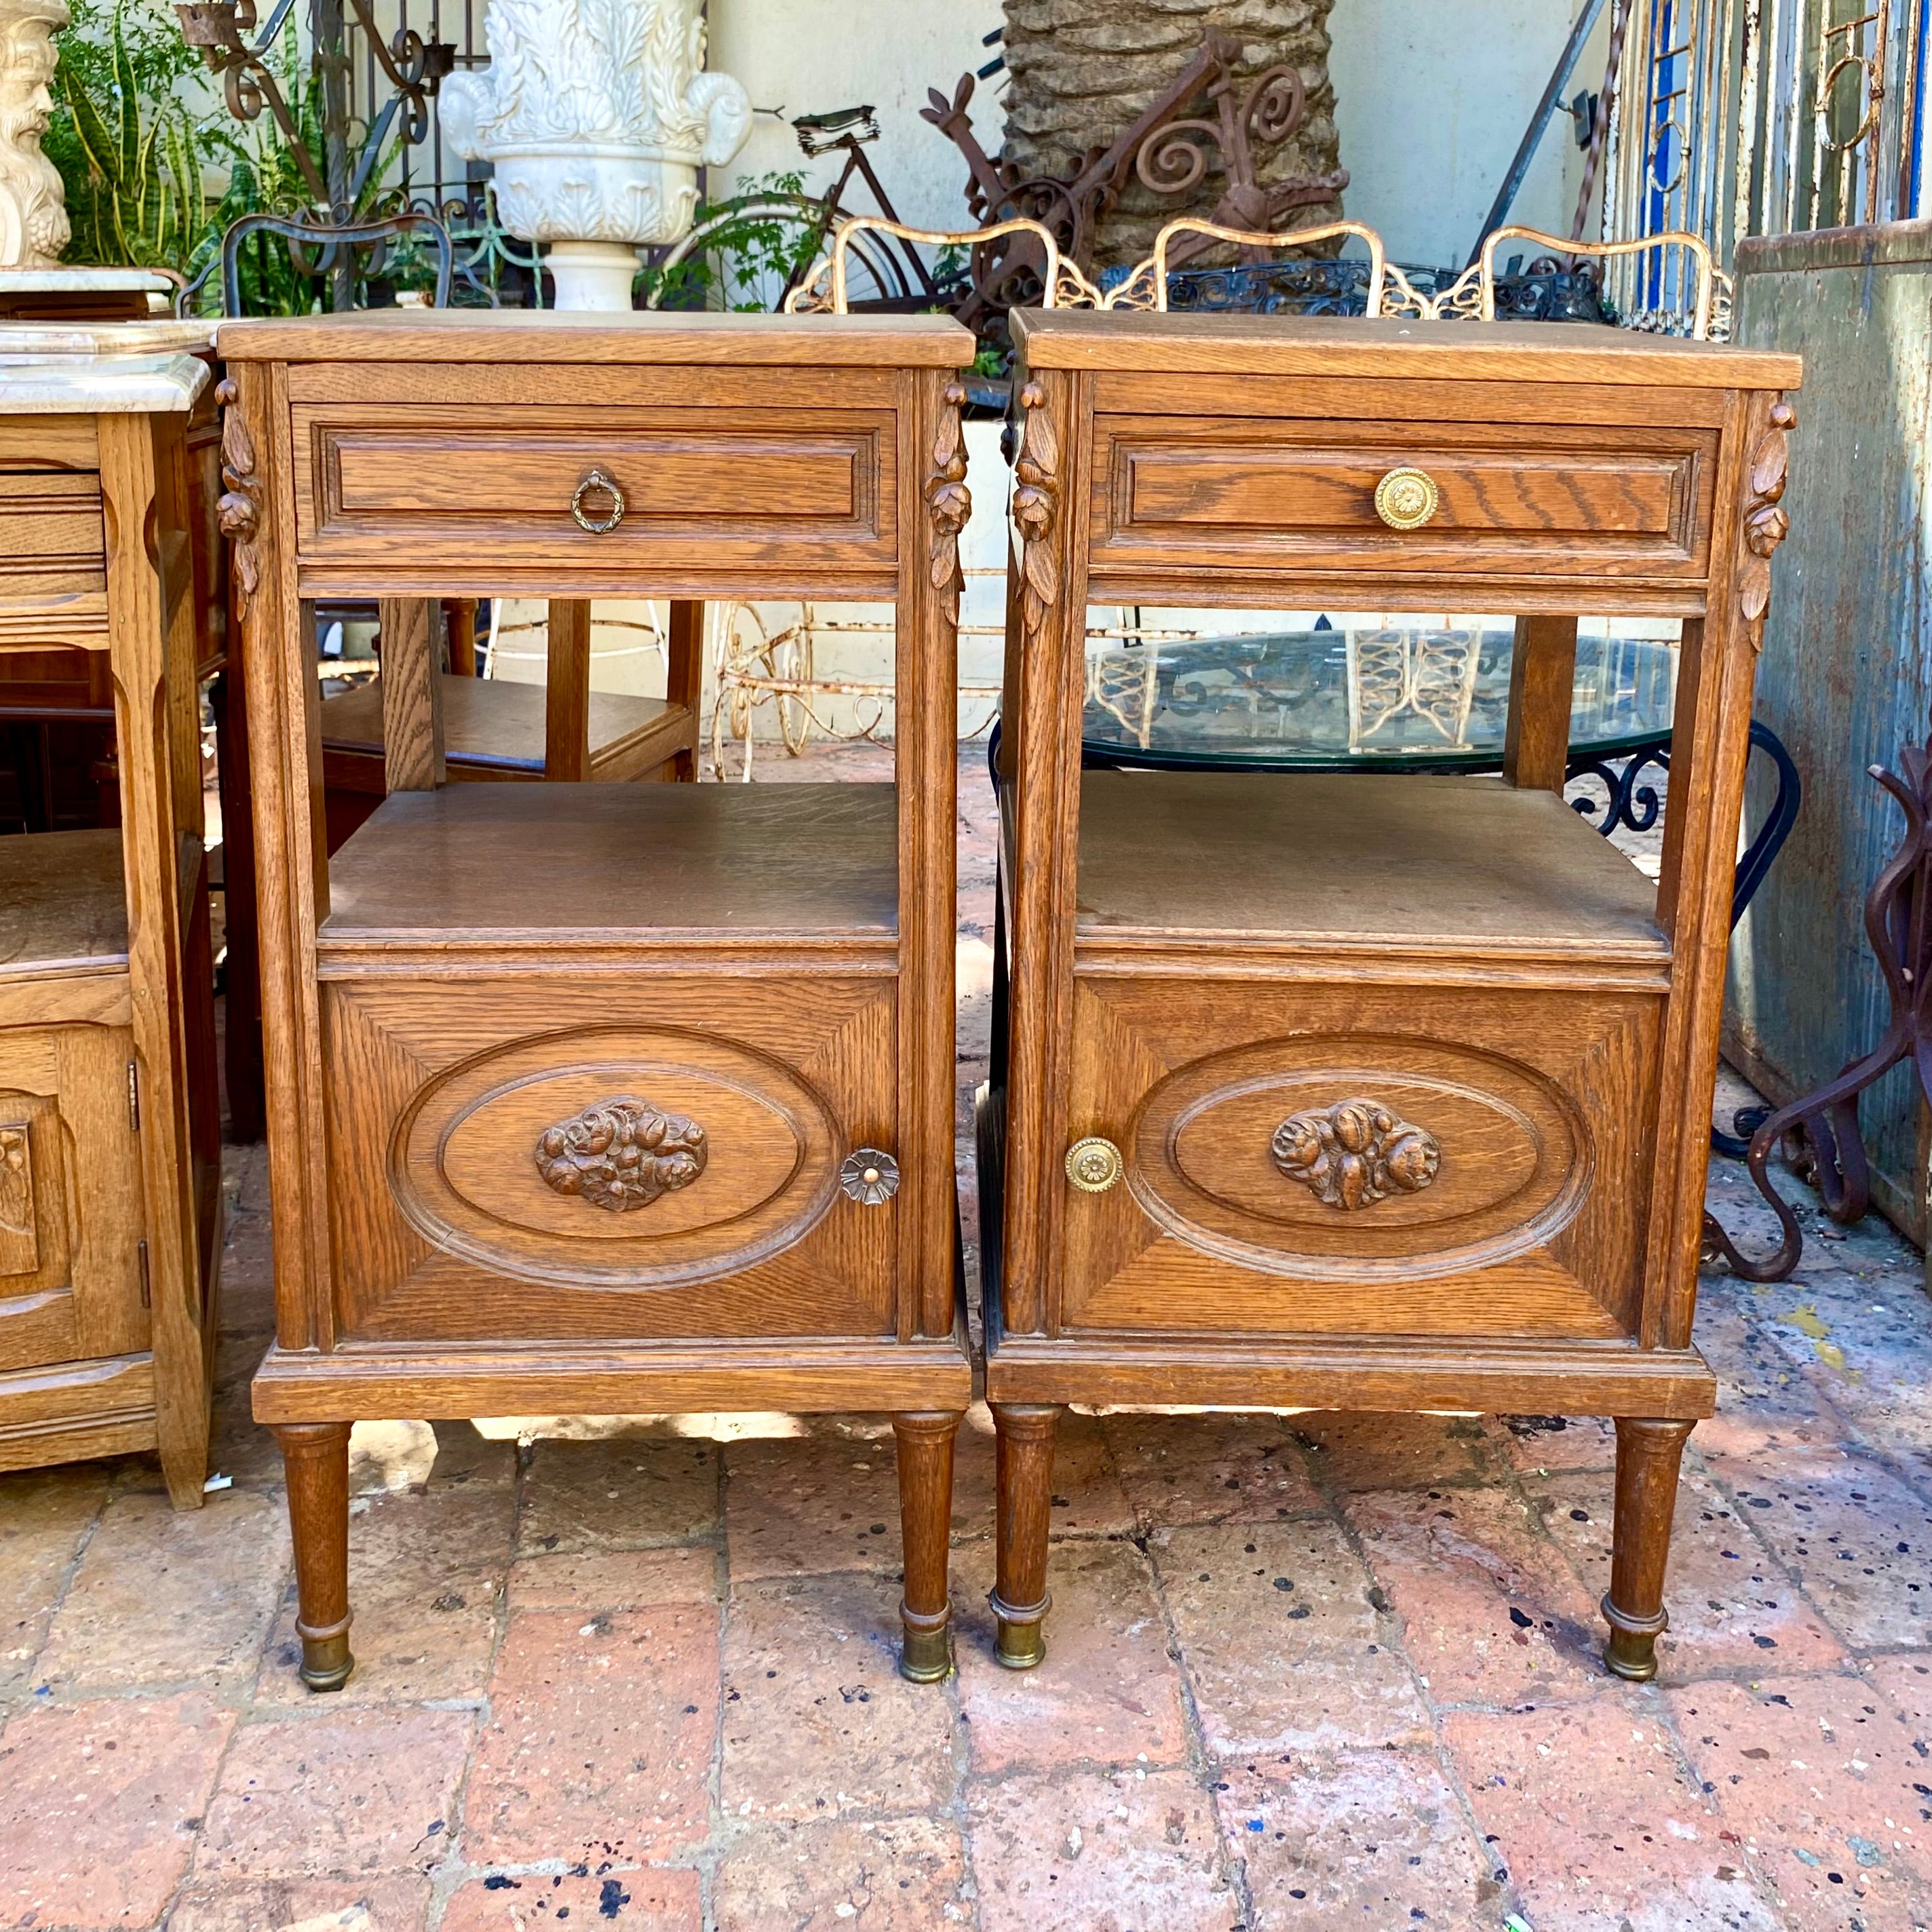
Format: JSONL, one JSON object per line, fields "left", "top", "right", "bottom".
{"left": 707, "top": 0, "right": 1005, "bottom": 228}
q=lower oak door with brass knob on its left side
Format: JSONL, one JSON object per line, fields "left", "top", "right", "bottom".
{"left": 1062, "top": 980, "right": 1659, "bottom": 1339}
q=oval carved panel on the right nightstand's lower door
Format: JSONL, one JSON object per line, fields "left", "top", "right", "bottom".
{"left": 1128, "top": 1034, "right": 1592, "bottom": 1279}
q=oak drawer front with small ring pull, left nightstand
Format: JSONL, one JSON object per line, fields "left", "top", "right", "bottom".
{"left": 296, "top": 406, "right": 895, "bottom": 572}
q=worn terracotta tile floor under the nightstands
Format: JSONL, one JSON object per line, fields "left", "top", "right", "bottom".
{"left": 0, "top": 752, "right": 1932, "bottom": 1932}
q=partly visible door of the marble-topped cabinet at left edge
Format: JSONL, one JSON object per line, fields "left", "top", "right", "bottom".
{"left": 0, "top": 1026, "right": 149, "bottom": 1370}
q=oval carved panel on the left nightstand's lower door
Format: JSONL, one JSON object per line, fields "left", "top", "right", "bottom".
{"left": 390, "top": 1026, "right": 843, "bottom": 1287}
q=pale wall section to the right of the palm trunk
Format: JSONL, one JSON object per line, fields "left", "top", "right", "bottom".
{"left": 1321, "top": 0, "right": 1611, "bottom": 269}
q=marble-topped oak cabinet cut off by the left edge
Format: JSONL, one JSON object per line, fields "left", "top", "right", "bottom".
{"left": 0, "top": 323, "right": 223, "bottom": 1509}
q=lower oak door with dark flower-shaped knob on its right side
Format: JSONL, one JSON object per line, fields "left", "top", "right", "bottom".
{"left": 324, "top": 980, "right": 896, "bottom": 1341}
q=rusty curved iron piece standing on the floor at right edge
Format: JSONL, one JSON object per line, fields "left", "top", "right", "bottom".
{"left": 1704, "top": 718, "right": 1932, "bottom": 1281}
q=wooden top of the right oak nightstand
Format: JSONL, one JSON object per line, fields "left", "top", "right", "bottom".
{"left": 1011, "top": 309, "right": 1804, "bottom": 388}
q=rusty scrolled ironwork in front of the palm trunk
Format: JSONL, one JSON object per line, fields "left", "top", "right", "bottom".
{"left": 920, "top": 31, "right": 1349, "bottom": 338}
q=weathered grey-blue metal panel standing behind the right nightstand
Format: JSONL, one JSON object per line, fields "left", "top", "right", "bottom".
{"left": 1725, "top": 223, "right": 1932, "bottom": 1242}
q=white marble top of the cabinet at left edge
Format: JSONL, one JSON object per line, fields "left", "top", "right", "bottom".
{"left": 0, "top": 321, "right": 214, "bottom": 415}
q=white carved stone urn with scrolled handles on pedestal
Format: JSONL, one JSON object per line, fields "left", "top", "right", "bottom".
{"left": 444, "top": 0, "right": 752, "bottom": 309}
